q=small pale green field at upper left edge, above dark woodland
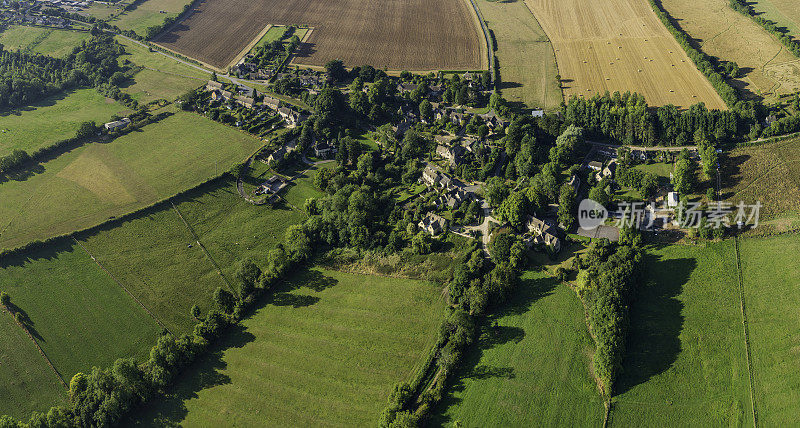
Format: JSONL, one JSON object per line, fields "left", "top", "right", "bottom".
{"left": 0, "top": 25, "right": 91, "bottom": 58}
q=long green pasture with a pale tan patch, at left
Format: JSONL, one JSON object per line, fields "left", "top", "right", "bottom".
{"left": 0, "top": 112, "right": 262, "bottom": 248}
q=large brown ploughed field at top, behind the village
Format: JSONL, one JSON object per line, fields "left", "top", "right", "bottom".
{"left": 156, "top": 0, "right": 488, "bottom": 71}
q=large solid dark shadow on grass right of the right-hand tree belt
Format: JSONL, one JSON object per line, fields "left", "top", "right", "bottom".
{"left": 614, "top": 255, "right": 697, "bottom": 395}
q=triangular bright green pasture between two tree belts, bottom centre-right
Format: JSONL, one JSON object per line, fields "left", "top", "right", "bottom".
{"left": 433, "top": 272, "right": 605, "bottom": 427}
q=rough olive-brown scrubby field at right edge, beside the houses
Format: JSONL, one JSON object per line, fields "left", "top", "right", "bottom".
{"left": 722, "top": 138, "right": 800, "bottom": 224}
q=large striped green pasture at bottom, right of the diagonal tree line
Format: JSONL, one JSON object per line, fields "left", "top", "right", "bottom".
{"left": 133, "top": 269, "right": 444, "bottom": 426}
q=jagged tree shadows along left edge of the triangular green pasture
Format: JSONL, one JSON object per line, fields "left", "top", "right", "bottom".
{"left": 426, "top": 277, "right": 558, "bottom": 426}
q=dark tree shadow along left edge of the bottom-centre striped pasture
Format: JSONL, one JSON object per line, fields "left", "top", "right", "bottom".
{"left": 121, "top": 325, "right": 255, "bottom": 427}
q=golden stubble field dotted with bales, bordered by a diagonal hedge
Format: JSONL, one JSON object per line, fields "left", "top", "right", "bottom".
{"left": 526, "top": 0, "right": 725, "bottom": 109}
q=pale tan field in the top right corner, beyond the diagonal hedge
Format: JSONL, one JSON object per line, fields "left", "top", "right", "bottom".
{"left": 662, "top": 0, "right": 800, "bottom": 100}
